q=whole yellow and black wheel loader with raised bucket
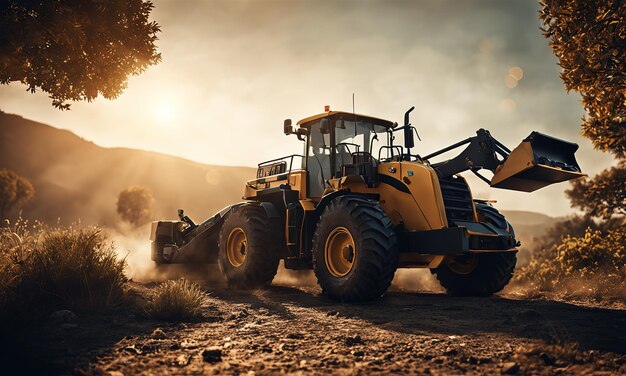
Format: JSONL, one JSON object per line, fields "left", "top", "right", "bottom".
{"left": 151, "top": 108, "right": 584, "bottom": 301}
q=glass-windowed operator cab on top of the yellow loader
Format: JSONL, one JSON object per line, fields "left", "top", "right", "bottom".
{"left": 297, "top": 111, "right": 396, "bottom": 197}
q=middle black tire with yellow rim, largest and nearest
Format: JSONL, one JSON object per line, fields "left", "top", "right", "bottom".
{"left": 313, "top": 196, "right": 398, "bottom": 301}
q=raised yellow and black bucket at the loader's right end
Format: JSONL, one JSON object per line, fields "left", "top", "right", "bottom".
{"left": 491, "top": 132, "right": 586, "bottom": 192}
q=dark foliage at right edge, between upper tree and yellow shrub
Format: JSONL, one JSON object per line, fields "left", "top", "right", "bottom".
{"left": 565, "top": 160, "right": 626, "bottom": 219}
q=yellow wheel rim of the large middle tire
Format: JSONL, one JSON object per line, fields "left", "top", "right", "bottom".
{"left": 324, "top": 227, "right": 356, "bottom": 277}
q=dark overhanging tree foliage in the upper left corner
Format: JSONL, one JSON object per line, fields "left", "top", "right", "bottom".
{"left": 0, "top": 0, "right": 161, "bottom": 110}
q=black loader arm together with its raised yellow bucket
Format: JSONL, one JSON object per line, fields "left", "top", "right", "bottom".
{"left": 422, "top": 129, "right": 585, "bottom": 192}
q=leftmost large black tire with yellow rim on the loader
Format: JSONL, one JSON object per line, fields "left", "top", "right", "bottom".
{"left": 218, "top": 205, "right": 281, "bottom": 289}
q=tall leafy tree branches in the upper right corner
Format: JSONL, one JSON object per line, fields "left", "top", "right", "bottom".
{"left": 540, "top": 0, "right": 626, "bottom": 158}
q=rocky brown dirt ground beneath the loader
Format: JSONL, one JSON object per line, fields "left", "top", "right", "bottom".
{"left": 4, "top": 278, "right": 626, "bottom": 376}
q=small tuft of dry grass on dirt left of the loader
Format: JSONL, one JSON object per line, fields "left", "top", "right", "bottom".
{"left": 145, "top": 278, "right": 207, "bottom": 321}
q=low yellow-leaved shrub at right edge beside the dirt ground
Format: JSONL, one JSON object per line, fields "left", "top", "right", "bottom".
{"left": 516, "top": 227, "right": 626, "bottom": 299}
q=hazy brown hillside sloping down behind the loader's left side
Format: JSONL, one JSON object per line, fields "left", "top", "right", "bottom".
{"left": 0, "top": 112, "right": 255, "bottom": 225}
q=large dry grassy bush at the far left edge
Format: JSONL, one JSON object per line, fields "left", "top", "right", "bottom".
{"left": 0, "top": 222, "right": 127, "bottom": 326}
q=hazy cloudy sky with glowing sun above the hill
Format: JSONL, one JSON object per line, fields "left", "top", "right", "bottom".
{"left": 0, "top": 0, "right": 614, "bottom": 216}
